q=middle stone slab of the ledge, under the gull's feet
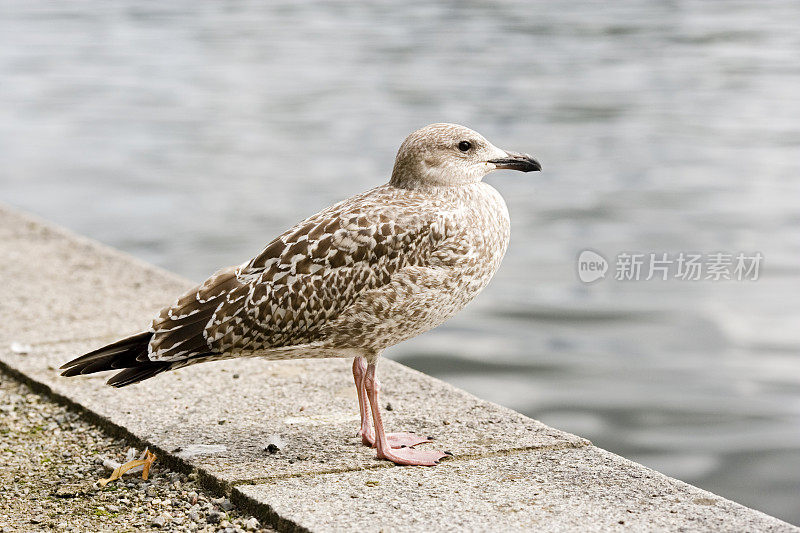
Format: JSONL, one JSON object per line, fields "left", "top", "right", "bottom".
{"left": 0, "top": 342, "right": 588, "bottom": 484}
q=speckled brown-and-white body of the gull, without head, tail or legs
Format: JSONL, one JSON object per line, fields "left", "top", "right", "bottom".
{"left": 149, "top": 182, "right": 509, "bottom": 363}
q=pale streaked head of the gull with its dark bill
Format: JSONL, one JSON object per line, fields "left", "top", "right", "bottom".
{"left": 391, "top": 123, "right": 542, "bottom": 188}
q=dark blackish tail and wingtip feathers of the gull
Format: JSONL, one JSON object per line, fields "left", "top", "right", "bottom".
{"left": 61, "top": 331, "right": 172, "bottom": 387}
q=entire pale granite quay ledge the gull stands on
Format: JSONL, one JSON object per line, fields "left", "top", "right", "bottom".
{"left": 0, "top": 202, "right": 800, "bottom": 531}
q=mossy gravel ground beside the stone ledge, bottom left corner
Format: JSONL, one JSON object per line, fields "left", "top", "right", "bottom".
{"left": 0, "top": 374, "right": 274, "bottom": 533}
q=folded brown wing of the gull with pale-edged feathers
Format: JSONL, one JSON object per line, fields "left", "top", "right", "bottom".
{"left": 147, "top": 189, "right": 444, "bottom": 361}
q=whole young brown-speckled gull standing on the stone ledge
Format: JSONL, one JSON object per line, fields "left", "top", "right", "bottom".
{"left": 61, "top": 123, "right": 541, "bottom": 466}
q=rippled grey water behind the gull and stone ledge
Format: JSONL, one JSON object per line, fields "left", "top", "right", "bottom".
{"left": 0, "top": 0, "right": 800, "bottom": 523}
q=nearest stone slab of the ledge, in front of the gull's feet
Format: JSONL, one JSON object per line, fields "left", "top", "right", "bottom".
{"left": 237, "top": 447, "right": 792, "bottom": 532}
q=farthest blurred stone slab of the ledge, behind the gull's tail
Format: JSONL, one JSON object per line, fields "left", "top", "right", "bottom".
{"left": 0, "top": 204, "right": 191, "bottom": 345}
